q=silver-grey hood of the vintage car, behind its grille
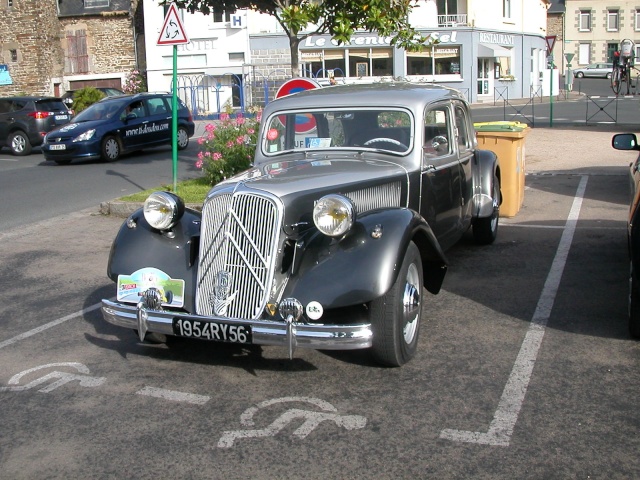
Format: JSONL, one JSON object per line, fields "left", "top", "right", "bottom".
{"left": 210, "top": 154, "right": 408, "bottom": 224}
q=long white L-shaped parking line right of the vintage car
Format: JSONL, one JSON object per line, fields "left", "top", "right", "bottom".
{"left": 440, "top": 176, "right": 589, "bottom": 447}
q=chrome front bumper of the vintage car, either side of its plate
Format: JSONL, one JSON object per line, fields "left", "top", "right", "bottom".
{"left": 102, "top": 299, "right": 373, "bottom": 357}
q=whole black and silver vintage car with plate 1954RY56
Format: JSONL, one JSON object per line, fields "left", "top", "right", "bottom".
{"left": 102, "top": 82, "right": 501, "bottom": 366}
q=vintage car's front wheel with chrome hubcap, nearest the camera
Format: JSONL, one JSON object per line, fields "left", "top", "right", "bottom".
{"left": 369, "top": 242, "right": 423, "bottom": 367}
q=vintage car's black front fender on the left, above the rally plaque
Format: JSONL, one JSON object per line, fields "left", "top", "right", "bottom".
{"left": 107, "top": 209, "right": 202, "bottom": 312}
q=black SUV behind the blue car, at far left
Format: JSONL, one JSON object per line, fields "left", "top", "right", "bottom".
{"left": 0, "top": 97, "right": 71, "bottom": 155}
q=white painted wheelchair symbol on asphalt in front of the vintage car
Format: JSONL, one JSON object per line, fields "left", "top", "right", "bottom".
{"left": 218, "top": 397, "right": 367, "bottom": 448}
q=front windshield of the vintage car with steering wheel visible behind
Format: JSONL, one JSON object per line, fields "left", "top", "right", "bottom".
{"left": 262, "top": 108, "right": 414, "bottom": 155}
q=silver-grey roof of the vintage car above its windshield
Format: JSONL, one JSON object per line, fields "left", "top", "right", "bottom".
{"left": 269, "top": 82, "right": 466, "bottom": 109}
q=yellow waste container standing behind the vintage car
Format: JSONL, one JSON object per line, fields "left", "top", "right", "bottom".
{"left": 473, "top": 122, "right": 531, "bottom": 217}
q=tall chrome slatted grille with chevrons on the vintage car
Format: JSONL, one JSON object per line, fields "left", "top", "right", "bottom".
{"left": 196, "top": 191, "right": 282, "bottom": 319}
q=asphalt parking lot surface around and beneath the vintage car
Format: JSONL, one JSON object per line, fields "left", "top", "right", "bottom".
{"left": 0, "top": 125, "right": 640, "bottom": 479}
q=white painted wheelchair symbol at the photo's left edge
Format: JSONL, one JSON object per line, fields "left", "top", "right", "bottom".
{"left": 0, "top": 362, "right": 106, "bottom": 393}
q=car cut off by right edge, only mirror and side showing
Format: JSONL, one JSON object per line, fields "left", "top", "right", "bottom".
{"left": 611, "top": 133, "right": 640, "bottom": 339}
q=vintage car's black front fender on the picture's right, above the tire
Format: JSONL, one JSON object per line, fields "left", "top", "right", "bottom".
{"left": 283, "top": 209, "right": 447, "bottom": 309}
